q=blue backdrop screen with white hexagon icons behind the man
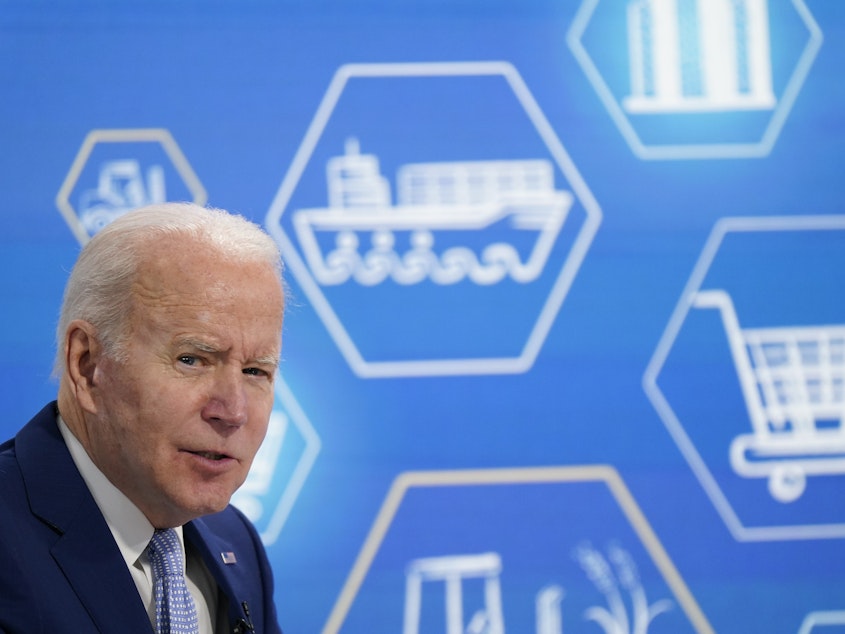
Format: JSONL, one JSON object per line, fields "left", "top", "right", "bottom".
{"left": 0, "top": 0, "right": 845, "bottom": 634}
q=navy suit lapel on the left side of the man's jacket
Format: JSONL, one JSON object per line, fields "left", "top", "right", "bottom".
{"left": 15, "top": 404, "right": 151, "bottom": 634}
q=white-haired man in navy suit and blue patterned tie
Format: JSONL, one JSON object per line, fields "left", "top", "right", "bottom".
{"left": 0, "top": 204, "right": 284, "bottom": 634}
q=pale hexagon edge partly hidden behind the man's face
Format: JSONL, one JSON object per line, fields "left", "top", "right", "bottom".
{"left": 252, "top": 376, "right": 322, "bottom": 546}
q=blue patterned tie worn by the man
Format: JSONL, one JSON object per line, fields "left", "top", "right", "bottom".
{"left": 148, "top": 528, "right": 199, "bottom": 634}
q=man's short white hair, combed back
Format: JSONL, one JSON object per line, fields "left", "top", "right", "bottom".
{"left": 54, "top": 203, "right": 284, "bottom": 376}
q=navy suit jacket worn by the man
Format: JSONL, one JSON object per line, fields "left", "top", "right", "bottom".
{"left": 0, "top": 403, "right": 281, "bottom": 634}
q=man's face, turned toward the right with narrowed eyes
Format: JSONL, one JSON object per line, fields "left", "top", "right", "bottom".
{"left": 87, "top": 240, "right": 283, "bottom": 527}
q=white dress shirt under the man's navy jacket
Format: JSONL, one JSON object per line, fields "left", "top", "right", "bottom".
{"left": 59, "top": 417, "right": 225, "bottom": 634}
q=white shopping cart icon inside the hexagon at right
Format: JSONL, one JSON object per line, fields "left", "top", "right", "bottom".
{"left": 693, "top": 290, "right": 845, "bottom": 502}
